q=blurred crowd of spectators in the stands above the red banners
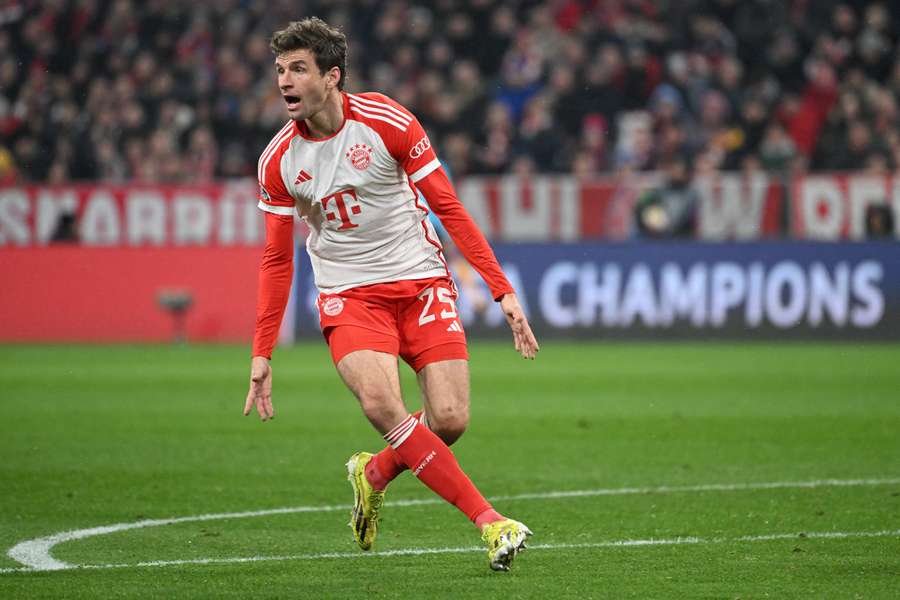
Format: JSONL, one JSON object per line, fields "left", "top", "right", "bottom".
{"left": 0, "top": 0, "right": 900, "bottom": 182}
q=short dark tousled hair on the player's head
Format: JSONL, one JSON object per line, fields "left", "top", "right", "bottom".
{"left": 269, "top": 17, "right": 347, "bottom": 90}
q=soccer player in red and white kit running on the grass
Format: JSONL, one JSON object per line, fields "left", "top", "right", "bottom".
{"left": 244, "top": 18, "right": 539, "bottom": 571}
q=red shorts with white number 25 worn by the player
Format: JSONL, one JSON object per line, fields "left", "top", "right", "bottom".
{"left": 316, "top": 276, "right": 469, "bottom": 372}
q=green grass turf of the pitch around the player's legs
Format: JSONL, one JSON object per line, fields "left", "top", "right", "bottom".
{"left": 0, "top": 342, "right": 900, "bottom": 598}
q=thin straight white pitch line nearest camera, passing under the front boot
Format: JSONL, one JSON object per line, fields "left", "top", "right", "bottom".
{"left": 0, "top": 529, "right": 900, "bottom": 573}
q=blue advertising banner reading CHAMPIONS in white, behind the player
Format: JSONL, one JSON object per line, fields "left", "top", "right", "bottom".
{"left": 295, "top": 242, "right": 900, "bottom": 340}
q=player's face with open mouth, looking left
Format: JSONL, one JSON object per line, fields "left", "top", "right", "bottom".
{"left": 275, "top": 50, "right": 334, "bottom": 121}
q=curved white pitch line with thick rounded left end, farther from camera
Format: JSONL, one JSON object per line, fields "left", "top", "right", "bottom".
{"left": 8, "top": 477, "right": 900, "bottom": 572}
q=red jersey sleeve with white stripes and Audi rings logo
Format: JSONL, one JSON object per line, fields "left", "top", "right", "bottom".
{"left": 358, "top": 94, "right": 441, "bottom": 183}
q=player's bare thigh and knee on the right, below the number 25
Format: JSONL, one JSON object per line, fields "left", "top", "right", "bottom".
{"left": 416, "top": 359, "right": 469, "bottom": 441}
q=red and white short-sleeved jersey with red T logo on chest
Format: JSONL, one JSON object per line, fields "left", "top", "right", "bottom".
{"left": 258, "top": 92, "right": 448, "bottom": 293}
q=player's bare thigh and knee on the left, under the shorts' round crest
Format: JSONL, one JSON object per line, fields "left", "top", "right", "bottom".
{"left": 336, "top": 350, "right": 407, "bottom": 435}
